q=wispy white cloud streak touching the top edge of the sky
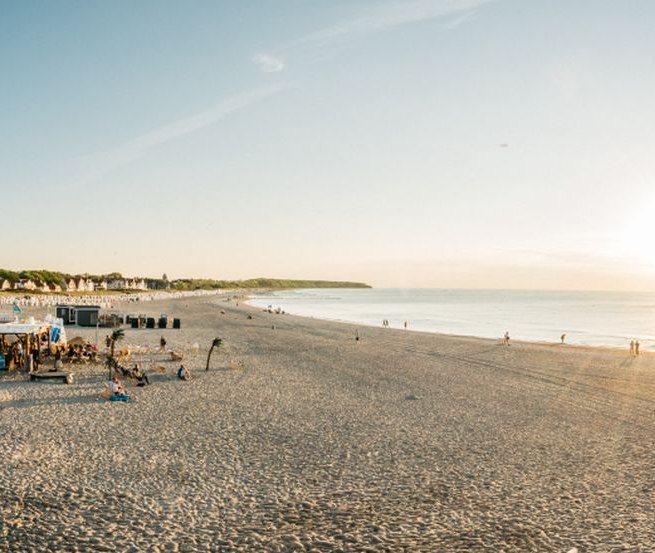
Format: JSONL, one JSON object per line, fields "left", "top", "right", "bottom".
{"left": 296, "top": 0, "right": 494, "bottom": 44}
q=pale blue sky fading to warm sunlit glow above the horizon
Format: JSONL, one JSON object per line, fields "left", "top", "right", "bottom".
{"left": 0, "top": 0, "right": 655, "bottom": 291}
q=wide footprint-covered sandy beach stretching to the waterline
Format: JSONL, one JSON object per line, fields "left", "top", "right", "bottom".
{"left": 0, "top": 297, "right": 655, "bottom": 553}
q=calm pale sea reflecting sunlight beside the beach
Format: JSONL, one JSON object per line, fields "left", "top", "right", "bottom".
{"left": 250, "top": 288, "right": 655, "bottom": 350}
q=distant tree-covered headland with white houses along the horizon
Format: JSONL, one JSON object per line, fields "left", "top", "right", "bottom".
{"left": 0, "top": 269, "right": 371, "bottom": 293}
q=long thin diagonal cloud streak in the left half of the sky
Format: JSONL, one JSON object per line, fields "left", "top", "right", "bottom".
{"left": 63, "top": 83, "right": 288, "bottom": 189}
